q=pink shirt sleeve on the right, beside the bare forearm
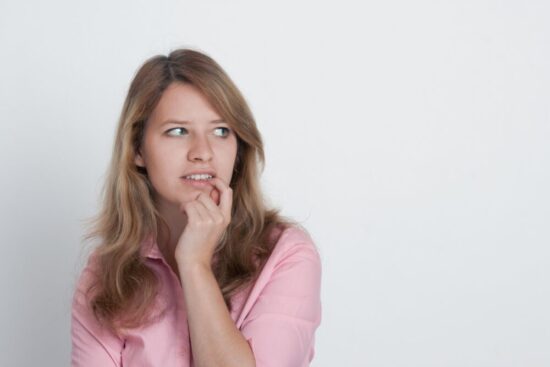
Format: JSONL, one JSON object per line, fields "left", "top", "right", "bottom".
{"left": 241, "top": 243, "right": 321, "bottom": 367}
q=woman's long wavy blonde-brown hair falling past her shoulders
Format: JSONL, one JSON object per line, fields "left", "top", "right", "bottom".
{"left": 83, "top": 49, "right": 297, "bottom": 335}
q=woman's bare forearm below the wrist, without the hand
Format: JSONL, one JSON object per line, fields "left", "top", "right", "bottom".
{"left": 178, "top": 264, "right": 255, "bottom": 367}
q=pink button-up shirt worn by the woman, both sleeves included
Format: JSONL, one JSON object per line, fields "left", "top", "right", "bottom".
{"left": 71, "top": 227, "right": 321, "bottom": 367}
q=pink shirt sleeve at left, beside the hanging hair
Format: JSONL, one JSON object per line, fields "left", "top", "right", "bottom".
{"left": 71, "top": 257, "right": 124, "bottom": 367}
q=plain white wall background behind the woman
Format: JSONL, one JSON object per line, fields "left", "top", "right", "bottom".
{"left": 0, "top": 0, "right": 550, "bottom": 367}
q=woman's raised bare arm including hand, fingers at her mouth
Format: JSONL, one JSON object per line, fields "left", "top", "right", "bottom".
{"left": 174, "top": 177, "right": 255, "bottom": 367}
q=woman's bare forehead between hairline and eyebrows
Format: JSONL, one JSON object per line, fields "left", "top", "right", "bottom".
{"left": 149, "top": 83, "right": 221, "bottom": 125}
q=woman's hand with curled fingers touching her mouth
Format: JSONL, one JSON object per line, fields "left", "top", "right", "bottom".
{"left": 175, "top": 177, "right": 233, "bottom": 267}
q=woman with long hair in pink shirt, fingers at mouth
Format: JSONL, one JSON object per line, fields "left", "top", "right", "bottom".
{"left": 71, "top": 49, "right": 321, "bottom": 367}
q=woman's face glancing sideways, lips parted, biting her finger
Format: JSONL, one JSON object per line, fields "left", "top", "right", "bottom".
{"left": 135, "top": 83, "right": 237, "bottom": 208}
